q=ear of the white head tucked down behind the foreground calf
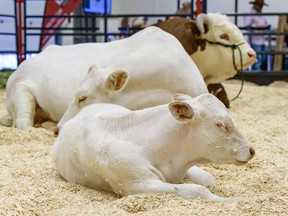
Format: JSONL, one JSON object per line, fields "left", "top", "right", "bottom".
{"left": 105, "top": 70, "right": 129, "bottom": 91}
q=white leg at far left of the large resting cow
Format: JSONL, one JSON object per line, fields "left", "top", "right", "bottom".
{"left": 8, "top": 84, "right": 36, "bottom": 130}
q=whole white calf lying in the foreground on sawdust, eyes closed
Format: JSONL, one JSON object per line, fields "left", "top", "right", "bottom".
{"left": 52, "top": 94, "right": 255, "bottom": 202}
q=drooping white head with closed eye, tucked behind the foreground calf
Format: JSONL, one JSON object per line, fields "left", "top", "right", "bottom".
{"left": 54, "top": 65, "right": 129, "bottom": 135}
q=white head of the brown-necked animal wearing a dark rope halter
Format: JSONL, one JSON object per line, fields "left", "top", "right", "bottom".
{"left": 186, "top": 14, "right": 256, "bottom": 84}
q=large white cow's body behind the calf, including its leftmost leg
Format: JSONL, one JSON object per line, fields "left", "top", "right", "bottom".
{"left": 6, "top": 27, "right": 208, "bottom": 130}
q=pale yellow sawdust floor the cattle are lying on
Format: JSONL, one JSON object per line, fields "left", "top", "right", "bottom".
{"left": 0, "top": 80, "right": 288, "bottom": 216}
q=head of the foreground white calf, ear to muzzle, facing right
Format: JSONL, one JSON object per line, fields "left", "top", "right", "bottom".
{"left": 169, "top": 94, "right": 255, "bottom": 165}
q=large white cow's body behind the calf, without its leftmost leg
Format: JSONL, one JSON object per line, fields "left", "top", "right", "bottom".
{"left": 7, "top": 27, "right": 207, "bottom": 121}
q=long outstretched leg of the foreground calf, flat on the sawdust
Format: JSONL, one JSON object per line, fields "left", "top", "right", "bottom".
{"left": 128, "top": 179, "right": 239, "bottom": 202}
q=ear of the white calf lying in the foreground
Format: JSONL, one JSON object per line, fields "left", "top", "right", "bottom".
{"left": 169, "top": 101, "right": 194, "bottom": 122}
